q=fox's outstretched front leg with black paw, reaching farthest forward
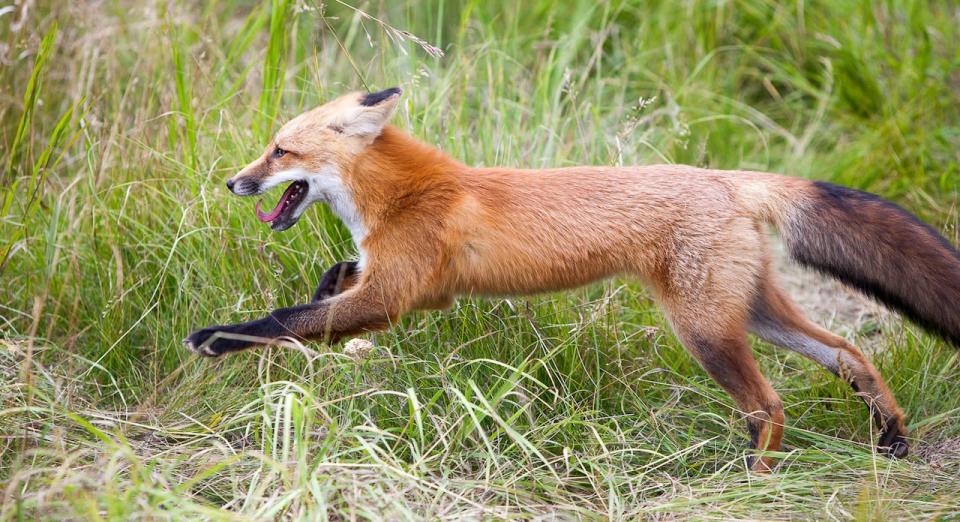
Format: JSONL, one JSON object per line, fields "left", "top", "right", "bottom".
{"left": 183, "top": 287, "right": 401, "bottom": 357}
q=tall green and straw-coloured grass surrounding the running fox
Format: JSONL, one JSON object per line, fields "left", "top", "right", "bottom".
{"left": 0, "top": 0, "right": 960, "bottom": 520}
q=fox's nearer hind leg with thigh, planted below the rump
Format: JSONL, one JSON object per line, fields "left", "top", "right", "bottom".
{"left": 653, "top": 217, "right": 784, "bottom": 472}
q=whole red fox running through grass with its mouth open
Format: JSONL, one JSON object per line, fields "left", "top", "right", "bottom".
{"left": 183, "top": 87, "right": 960, "bottom": 473}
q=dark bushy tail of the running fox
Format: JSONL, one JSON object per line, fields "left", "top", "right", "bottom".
{"left": 779, "top": 182, "right": 960, "bottom": 348}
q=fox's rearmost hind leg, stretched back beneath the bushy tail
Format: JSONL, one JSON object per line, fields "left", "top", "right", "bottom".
{"left": 749, "top": 279, "right": 909, "bottom": 457}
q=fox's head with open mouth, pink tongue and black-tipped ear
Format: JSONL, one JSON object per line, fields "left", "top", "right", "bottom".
{"left": 227, "top": 87, "right": 402, "bottom": 232}
